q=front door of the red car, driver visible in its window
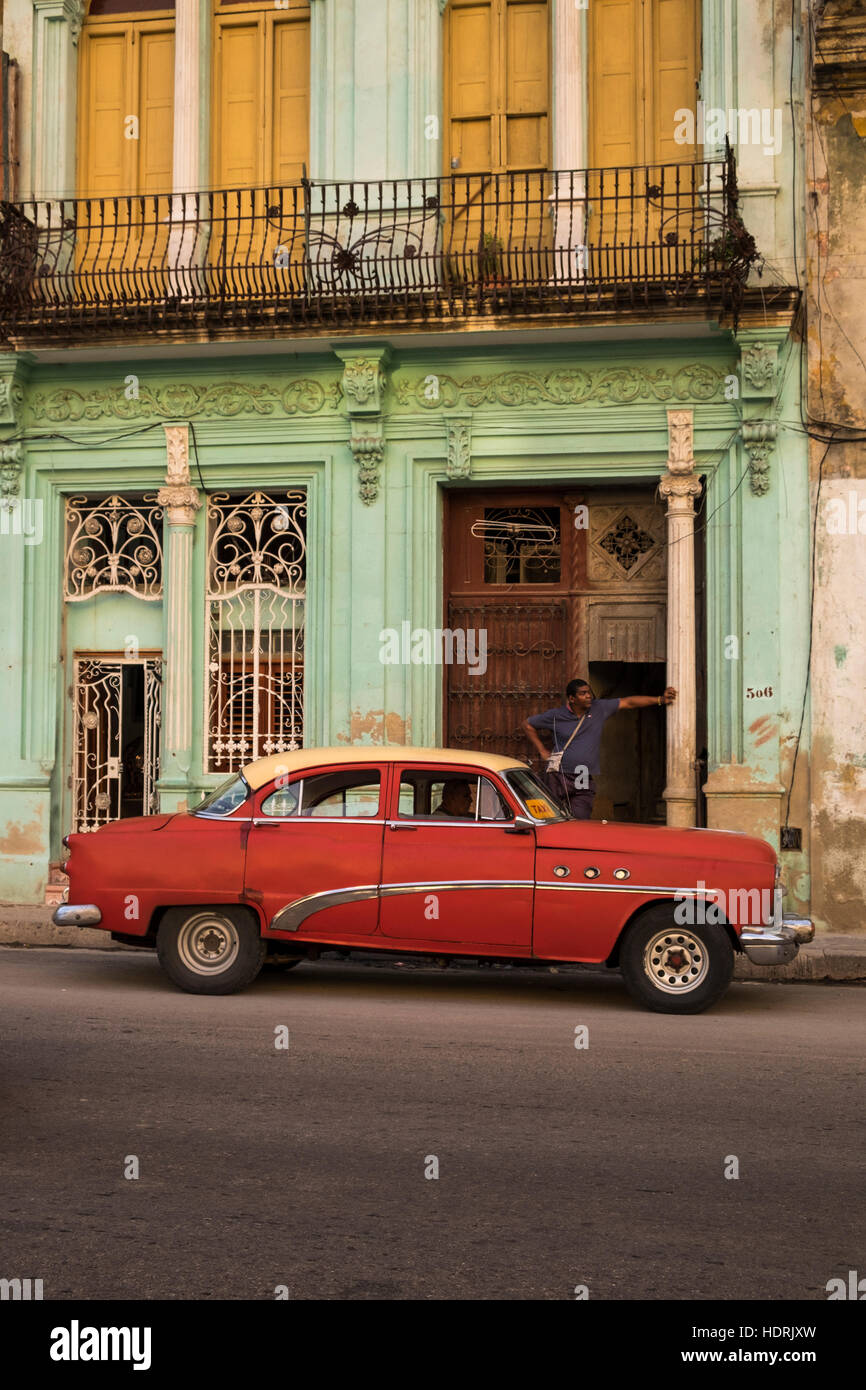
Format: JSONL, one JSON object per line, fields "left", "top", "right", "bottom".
{"left": 379, "top": 763, "right": 535, "bottom": 955}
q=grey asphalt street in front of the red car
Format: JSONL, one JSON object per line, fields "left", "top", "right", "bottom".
{"left": 0, "top": 949, "right": 866, "bottom": 1300}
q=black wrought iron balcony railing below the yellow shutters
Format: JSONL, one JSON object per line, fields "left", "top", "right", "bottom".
{"left": 0, "top": 152, "right": 756, "bottom": 341}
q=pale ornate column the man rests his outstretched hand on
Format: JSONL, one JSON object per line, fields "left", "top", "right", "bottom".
{"left": 659, "top": 410, "right": 701, "bottom": 826}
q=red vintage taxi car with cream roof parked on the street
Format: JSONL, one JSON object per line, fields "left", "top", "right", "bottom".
{"left": 53, "top": 748, "right": 813, "bottom": 1013}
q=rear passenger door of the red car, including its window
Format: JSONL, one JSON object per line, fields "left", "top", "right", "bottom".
{"left": 245, "top": 763, "right": 386, "bottom": 941}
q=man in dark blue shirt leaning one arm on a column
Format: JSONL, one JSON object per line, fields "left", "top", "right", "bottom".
{"left": 523, "top": 681, "right": 677, "bottom": 820}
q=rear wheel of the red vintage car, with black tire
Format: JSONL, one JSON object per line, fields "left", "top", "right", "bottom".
{"left": 157, "top": 908, "right": 265, "bottom": 994}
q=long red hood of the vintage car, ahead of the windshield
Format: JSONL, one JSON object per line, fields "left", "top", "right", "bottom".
{"left": 537, "top": 820, "right": 776, "bottom": 865}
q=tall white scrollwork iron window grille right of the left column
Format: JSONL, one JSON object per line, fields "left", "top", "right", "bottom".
{"left": 204, "top": 489, "right": 307, "bottom": 773}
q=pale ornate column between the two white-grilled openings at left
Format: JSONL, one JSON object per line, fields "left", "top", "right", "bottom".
{"left": 157, "top": 424, "right": 202, "bottom": 791}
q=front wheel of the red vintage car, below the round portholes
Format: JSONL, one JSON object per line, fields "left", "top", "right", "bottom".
{"left": 620, "top": 906, "right": 734, "bottom": 1013}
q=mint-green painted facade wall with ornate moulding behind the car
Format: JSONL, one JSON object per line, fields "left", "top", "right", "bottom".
{"left": 0, "top": 0, "right": 809, "bottom": 910}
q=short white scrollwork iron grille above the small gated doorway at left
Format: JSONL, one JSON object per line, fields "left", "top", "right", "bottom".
{"left": 64, "top": 492, "right": 163, "bottom": 603}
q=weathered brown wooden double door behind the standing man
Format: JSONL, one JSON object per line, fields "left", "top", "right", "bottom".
{"left": 443, "top": 488, "right": 667, "bottom": 821}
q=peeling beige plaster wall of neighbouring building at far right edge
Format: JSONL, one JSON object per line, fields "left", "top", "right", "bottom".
{"left": 798, "top": 0, "right": 866, "bottom": 931}
